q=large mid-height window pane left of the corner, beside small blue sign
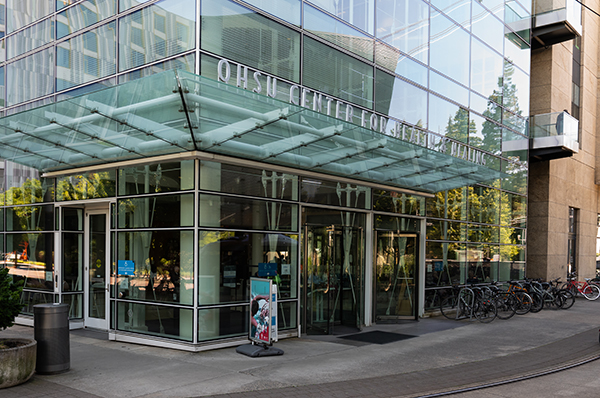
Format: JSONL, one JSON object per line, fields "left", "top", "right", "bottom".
{"left": 117, "top": 230, "right": 194, "bottom": 305}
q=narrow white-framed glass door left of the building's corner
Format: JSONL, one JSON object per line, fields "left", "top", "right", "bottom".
{"left": 85, "top": 210, "right": 110, "bottom": 329}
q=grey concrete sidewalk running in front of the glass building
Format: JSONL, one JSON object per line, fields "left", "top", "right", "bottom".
{"left": 0, "top": 299, "right": 600, "bottom": 398}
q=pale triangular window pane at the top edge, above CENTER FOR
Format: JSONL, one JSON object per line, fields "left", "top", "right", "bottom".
{"left": 311, "top": 0, "right": 375, "bottom": 34}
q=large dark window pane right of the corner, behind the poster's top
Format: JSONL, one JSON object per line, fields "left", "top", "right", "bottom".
{"left": 198, "top": 231, "right": 298, "bottom": 305}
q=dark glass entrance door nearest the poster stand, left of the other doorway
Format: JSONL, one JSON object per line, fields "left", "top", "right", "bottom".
{"left": 304, "top": 225, "right": 363, "bottom": 334}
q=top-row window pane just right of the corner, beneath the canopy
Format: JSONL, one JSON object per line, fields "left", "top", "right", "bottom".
{"left": 200, "top": 161, "right": 298, "bottom": 200}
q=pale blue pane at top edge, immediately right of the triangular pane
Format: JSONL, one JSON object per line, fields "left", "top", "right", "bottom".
{"left": 377, "top": 0, "right": 429, "bottom": 63}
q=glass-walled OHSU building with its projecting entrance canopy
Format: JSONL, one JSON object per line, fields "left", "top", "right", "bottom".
{"left": 0, "top": 0, "right": 531, "bottom": 350}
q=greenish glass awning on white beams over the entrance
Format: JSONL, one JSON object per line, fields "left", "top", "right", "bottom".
{"left": 0, "top": 71, "right": 504, "bottom": 192}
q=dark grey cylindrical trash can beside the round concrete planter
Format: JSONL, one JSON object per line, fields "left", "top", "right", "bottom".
{"left": 33, "top": 304, "right": 71, "bottom": 374}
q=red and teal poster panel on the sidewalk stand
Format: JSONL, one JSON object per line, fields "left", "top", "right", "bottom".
{"left": 249, "top": 278, "right": 273, "bottom": 344}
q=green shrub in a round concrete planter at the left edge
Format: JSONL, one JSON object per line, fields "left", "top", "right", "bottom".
{"left": 0, "top": 268, "right": 37, "bottom": 389}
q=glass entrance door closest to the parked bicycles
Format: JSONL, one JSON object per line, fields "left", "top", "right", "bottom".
{"left": 374, "top": 231, "right": 418, "bottom": 320}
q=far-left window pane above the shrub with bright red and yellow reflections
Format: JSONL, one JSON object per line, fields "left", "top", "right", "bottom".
{"left": 4, "top": 233, "right": 54, "bottom": 291}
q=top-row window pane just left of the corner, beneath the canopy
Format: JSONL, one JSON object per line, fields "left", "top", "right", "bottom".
{"left": 119, "top": 160, "right": 194, "bottom": 195}
